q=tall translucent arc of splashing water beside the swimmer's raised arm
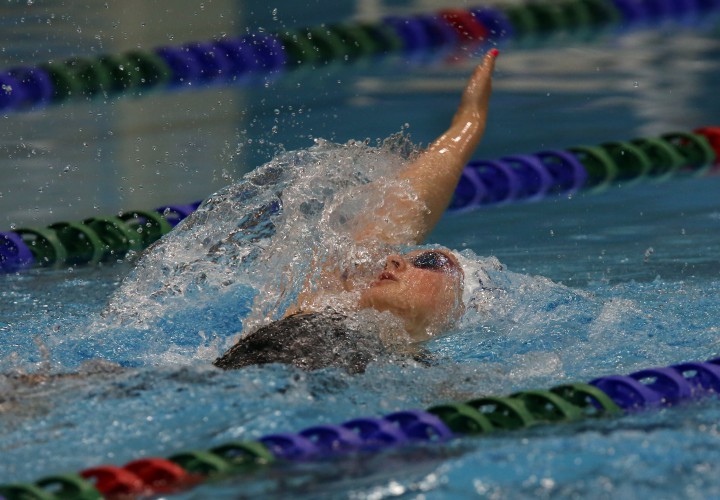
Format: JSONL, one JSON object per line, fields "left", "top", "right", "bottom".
{"left": 90, "top": 134, "right": 424, "bottom": 364}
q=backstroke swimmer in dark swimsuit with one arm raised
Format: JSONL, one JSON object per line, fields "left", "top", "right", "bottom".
{"left": 214, "top": 49, "right": 498, "bottom": 372}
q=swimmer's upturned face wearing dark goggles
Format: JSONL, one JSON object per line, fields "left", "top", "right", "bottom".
{"left": 360, "top": 250, "right": 463, "bottom": 340}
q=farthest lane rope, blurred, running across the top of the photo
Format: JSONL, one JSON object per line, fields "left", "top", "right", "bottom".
{"left": 0, "top": 0, "right": 720, "bottom": 112}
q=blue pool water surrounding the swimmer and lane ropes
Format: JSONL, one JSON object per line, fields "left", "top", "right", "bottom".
{"left": 0, "top": 1, "right": 720, "bottom": 498}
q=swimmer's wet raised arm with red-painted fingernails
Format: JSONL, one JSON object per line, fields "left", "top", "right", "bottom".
{"left": 355, "top": 49, "right": 498, "bottom": 244}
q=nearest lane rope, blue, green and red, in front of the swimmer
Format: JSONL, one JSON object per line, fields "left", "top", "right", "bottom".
{"left": 0, "top": 358, "right": 720, "bottom": 500}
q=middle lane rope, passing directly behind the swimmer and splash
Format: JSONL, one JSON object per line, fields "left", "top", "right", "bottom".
{"left": 0, "top": 127, "right": 720, "bottom": 273}
